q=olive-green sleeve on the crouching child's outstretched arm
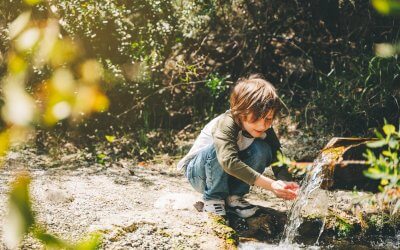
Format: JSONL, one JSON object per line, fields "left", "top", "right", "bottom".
{"left": 212, "top": 113, "right": 260, "bottom": 185}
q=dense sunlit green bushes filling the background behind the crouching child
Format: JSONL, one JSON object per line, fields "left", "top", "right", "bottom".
{"left": 0, "top": 0, "right": 400, "bottom": 158}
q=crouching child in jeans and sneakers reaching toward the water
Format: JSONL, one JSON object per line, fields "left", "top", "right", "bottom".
{"left": 178, "top": 75, "right": 299, "bottom": 218}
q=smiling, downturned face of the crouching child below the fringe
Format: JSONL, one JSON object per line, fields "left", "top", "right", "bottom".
{"left": 242, "top": 111, "right": 274, "bottom": 138}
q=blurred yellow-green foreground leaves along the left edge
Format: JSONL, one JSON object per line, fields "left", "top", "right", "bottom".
{"left": 0, "top": 0, "right": 108, "bottom": 249}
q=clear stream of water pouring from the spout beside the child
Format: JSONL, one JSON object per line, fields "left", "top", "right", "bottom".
{"left": 279, "top": 148, "right": 341, "bottom": 247}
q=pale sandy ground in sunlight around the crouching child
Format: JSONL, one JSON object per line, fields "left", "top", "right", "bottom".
{"left": 0, "top": 149, "right": 290, "bottom": 249}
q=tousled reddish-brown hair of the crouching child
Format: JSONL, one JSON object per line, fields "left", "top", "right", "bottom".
{"left": 230, "top": 74, "right": 281, "bottom": 126}
